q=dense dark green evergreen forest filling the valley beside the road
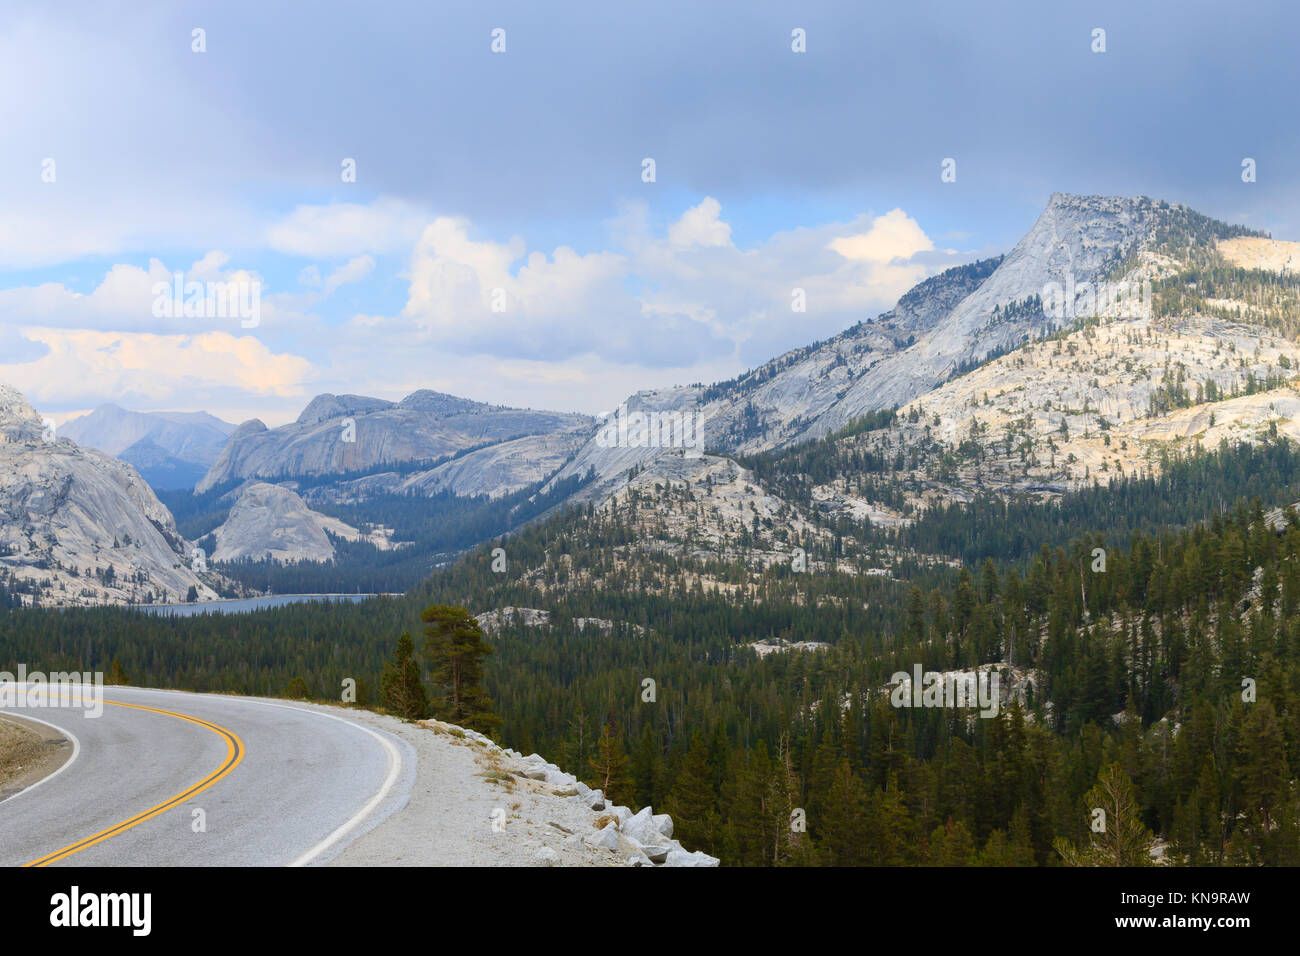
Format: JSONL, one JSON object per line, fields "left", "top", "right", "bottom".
{"left": 0, "top": 441, "right": 1300, "bottom": 865}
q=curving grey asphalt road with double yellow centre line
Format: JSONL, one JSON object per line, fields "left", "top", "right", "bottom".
{"left": 0, "top": 687, "right": 415, "bottom": 866}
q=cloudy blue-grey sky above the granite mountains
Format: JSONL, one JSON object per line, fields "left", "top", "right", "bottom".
{"left": 0, "top": 0, "right": 1300, "bottom": 427}
